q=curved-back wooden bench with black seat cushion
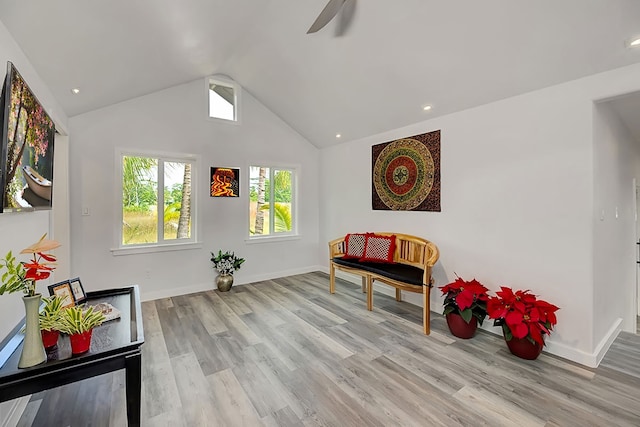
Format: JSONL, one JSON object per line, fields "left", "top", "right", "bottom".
{"left": 329, "top": 232, "right": 440, "bottom": 335}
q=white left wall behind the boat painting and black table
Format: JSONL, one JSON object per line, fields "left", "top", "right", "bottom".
{"left": 0, "top": 23, "right": 70, "bottom": 425}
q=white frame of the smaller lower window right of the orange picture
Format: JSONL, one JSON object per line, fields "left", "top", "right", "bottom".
{"left": 245, "top": 162, "right": 300, "bottom": 243}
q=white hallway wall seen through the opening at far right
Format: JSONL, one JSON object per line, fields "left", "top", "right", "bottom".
{"left": 593, "top": 102, "right": 640, "bottom": 343}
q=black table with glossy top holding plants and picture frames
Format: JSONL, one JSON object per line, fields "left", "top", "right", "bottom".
{"left": 0, "top": 285, "right": 144, "bottom": 426}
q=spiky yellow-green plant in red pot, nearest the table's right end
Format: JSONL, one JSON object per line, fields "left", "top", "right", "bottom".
{"left": 60, "top": 305, "right": 104, "bottom": 354}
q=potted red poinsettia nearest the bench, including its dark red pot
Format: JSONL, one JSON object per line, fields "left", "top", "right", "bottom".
{"left": 440, "top": 277, "right": 489, "bottom": 339}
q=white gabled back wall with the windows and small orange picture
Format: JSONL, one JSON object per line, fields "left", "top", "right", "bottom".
{"left": 70, "top": 79, "right": 319, "bottom": 299}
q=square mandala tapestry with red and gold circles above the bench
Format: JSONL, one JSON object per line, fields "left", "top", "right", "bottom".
{"left": 371, "top": 130, "right": 440, "bottom": 212}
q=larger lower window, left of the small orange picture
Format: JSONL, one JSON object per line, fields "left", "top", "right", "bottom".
{"left": 119, "top": 153, "right": 196, "bottom": 248}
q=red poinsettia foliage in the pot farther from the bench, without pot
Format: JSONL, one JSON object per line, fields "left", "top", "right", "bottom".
{"left": 487, "top": 286, "right": 559, "bottom": 346}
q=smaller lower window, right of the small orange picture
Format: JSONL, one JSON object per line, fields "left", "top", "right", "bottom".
{"left": 249, "top": 166, "right": 296, "bottom": 238}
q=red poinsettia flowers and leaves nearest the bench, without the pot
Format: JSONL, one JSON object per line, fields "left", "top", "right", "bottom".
{"left": 439, "top": 277, "right": 489, "bottom": 325}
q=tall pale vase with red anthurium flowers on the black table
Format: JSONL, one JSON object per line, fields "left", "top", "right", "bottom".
{"left": 0, "top": 233, "right": 60, "bottom": 368}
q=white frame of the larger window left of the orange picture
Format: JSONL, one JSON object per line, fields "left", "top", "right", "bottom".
{"left": 111, "top": 148, "right": 202, "bottom": 255}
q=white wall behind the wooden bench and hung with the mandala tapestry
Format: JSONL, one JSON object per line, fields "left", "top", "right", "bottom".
{"left": 321, "top": 61, "right": 640, "bottom": 366}
